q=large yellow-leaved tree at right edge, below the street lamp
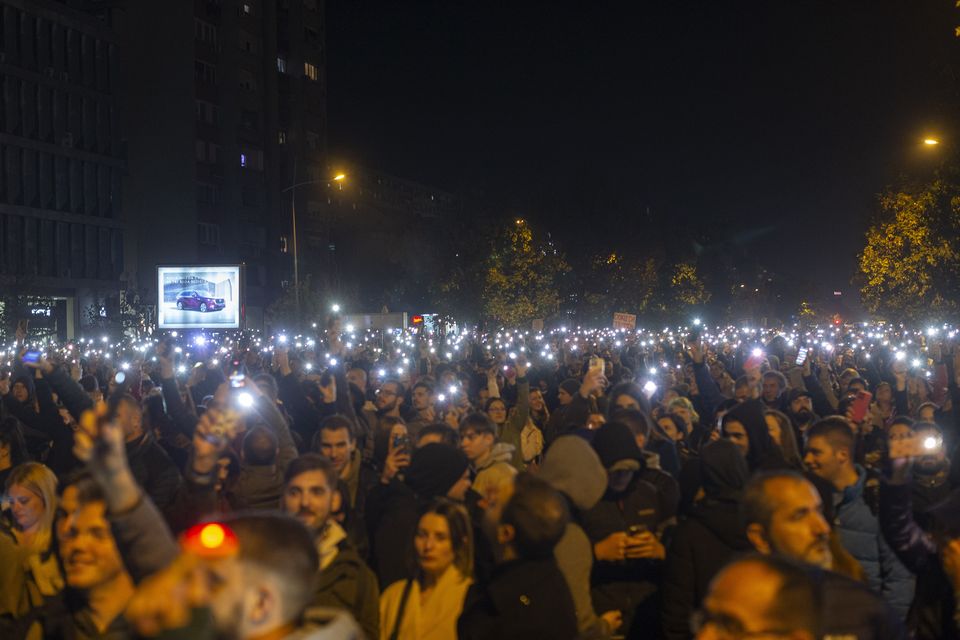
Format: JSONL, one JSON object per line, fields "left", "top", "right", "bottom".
{"left": 859, "top": 178, "right": 960, "bottom": 321}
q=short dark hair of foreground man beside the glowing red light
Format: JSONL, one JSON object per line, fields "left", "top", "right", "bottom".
{"left": 220, "top": 512, "right": 320, "bottom": 622}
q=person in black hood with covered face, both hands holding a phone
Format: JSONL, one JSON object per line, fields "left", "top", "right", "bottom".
{"left": 583, "top": 422, "right": 673, "bottom": 638}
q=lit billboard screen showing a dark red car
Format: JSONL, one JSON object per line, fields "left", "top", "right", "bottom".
{"left": 157, "top": 265, "right": 240, "bottom": 329}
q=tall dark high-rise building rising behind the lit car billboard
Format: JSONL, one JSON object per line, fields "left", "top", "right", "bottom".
{"left": 99, "top": 0, "right": 326, "bottom": 327}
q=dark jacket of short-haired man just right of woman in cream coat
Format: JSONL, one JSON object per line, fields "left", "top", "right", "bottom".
{"left": 457, "top": 556, "right": 577, "bottom": 640}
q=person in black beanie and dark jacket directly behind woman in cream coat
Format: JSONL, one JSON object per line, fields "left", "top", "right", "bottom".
{"left": 366, "top": 443, "right": 470, "bottom": 589}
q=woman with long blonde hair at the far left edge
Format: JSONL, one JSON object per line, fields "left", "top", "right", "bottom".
{"left": 0, "top": 462, "right": 63, "bottom": 638}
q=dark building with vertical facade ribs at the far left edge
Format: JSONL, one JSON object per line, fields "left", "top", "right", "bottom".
{"left": 0, "top": 0, "right": 126, "bottom": 338}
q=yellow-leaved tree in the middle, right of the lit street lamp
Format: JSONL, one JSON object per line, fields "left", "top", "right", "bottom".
{"left": 483, "top": 219, "right": 570, "bottom": 327}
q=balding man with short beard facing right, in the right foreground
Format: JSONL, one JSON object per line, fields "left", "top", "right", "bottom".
{"left": 741, "top": 471, "right": 905, "bottom": 640}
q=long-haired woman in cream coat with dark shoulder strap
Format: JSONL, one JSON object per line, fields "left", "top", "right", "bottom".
{"left": 380, "top": 498, "right": 473, "bottom": 640}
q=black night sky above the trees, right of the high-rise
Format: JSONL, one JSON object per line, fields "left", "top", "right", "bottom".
{"left": 327, "top": 0, "right": 960, "bottom": 290}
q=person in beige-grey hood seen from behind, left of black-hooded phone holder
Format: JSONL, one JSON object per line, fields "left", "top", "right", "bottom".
{"left": 539, "top": 435, "right": 622, "bottom": 638}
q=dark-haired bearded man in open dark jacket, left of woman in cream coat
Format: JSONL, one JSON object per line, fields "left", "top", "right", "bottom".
{"left": 281, "top": 454, "right": 380, "bottom": 638}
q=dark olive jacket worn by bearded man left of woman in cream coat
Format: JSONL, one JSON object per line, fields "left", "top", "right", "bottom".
{"left": 312, "top": 540, "right": 380, "bottom": 638}
